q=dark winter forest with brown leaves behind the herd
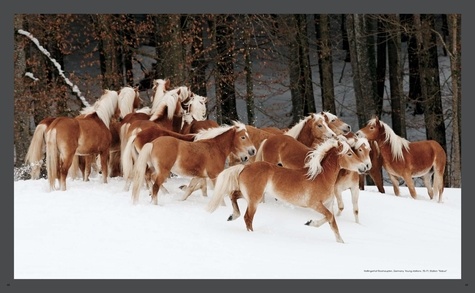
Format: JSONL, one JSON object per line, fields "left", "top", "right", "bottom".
{"left": 14, "top": 14, "right": 462, "bottom": 187}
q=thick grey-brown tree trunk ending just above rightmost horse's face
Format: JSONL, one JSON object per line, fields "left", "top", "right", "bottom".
{"left": 346, "top": 14, "right": 376, "bottom": 128}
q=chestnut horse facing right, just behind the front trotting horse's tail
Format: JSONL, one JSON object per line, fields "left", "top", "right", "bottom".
{"left": 132, "top": 122, "right": 256, "bottom": 204}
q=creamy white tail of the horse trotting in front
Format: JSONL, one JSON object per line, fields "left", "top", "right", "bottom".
{"left": 206, "top": 164, "right": 245, "bottom": 213}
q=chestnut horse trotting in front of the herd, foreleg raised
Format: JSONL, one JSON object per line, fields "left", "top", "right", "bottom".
{"left": 206, "top": 139, "right": 366, "bottom": 243}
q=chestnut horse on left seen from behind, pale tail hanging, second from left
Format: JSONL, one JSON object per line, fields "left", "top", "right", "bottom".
{"left": 45, "top": 90, "right": 118, "bottom": 190}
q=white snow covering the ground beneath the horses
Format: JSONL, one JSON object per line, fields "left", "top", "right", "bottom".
{"left": 14, "top": 174, "right": 462, "bottom": 279}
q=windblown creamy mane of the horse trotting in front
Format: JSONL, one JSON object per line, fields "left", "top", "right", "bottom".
{"left": 305, "top": 138, "right": 351, "bottom": 180}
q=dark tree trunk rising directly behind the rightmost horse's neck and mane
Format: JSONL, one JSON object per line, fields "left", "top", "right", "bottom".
{"left": 386, "top": 14, "right": 407, "bottom": 137}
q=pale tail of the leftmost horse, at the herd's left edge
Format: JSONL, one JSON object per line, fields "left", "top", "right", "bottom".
{"left": 25, "top": 123, "right": 48, "bottom": 179}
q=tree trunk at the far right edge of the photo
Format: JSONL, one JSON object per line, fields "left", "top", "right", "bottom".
{"left": 446, "top": 14, "right": 462, "bottom": 188}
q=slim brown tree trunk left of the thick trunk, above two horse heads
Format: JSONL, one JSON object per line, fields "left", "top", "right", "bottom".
{"left": 314, "top": 14, "right": 337, "bottom": 114}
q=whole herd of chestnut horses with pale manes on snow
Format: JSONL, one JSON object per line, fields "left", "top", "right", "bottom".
{"left": 26, "top": 79, "right": 446, "bottom": 243}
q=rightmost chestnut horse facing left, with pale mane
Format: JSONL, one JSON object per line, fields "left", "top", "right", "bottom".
{"left": 356, "top": 117, "right": 447, "bottom": 202}
